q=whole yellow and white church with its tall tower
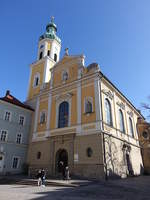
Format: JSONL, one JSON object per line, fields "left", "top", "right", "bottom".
{"left": 26, "top": 17, "right": 143, "bottom": 179}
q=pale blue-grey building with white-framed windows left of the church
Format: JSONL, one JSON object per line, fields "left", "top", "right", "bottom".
{"left": 0, "top": 91, "right": 33, "bottom": 174}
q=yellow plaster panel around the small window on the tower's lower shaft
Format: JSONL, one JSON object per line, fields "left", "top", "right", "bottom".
{"left": 28, "top": 62, "right": 44, "bottom": 99}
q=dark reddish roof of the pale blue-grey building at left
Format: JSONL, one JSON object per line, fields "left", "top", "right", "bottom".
{"left": 0, "top": 90, "right": 34, "bottom": 111}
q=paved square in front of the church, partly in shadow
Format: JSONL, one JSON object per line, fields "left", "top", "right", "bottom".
{"left": 0, "top": 176, "right": 150, "bottom": 200}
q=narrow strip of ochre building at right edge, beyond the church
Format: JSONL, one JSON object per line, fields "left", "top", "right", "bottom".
{"left": 138, "top": 118, "right": 150, "bottom": 174}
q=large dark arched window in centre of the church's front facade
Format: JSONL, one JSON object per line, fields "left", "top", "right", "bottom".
{"left": 58, "top": 101, "right": 69, "bottom": 128}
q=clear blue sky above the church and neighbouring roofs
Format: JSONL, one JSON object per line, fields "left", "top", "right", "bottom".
{"left": 0, "top": 0, "right": 150, "bottom": 119}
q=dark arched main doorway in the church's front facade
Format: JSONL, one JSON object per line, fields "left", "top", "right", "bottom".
{"left": 55, "top": 149, "right": 68, "bottom": 174}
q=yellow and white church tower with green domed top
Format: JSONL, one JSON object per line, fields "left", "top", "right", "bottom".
{"left": 27, "top": 17, "right": 61, "bottom": 100}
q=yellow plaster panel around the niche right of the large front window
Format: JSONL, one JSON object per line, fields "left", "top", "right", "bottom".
{"left": 81, "top": 84, "right": 96, "bottom": 123}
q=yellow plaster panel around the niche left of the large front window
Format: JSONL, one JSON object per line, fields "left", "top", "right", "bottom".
{"left": 37, "top": 99, "right": 48, "bottom": 132}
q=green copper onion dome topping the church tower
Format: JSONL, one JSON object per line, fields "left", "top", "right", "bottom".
{"left": 39, "top": 17, "right": 61, "bottom": 43}
